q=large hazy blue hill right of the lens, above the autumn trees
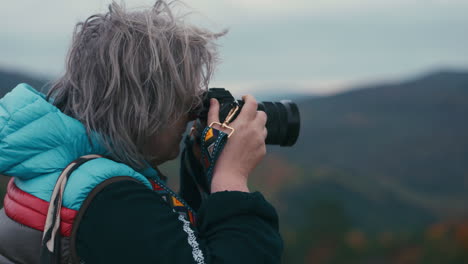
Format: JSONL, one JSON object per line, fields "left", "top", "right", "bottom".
{"left": 256, "top": 71, "right": 468, "bottom": 233}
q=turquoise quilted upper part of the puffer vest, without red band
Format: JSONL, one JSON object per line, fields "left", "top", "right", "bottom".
{"left": 0, "top": 84, "right": 157, "bottom": 207}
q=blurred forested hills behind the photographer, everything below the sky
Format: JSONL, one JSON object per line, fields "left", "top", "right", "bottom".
{"left": 0, "top": 71, "right": 468, "bottom": 264}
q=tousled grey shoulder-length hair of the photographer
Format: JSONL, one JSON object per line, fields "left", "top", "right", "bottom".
{"left": 47, "top": 0, "right": 226, "bottom": 168}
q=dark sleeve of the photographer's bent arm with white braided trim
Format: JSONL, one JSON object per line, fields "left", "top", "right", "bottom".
{"left": 76, "top": 181, "right": 283, "bottom": 264}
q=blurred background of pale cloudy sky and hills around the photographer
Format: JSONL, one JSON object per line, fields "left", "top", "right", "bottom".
{"left": 0, "top": 0, "right": 468, "bottom": 264}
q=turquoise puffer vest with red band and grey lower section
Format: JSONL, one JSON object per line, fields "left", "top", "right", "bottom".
{"left": 0, "top": 84, "right": 183, "bottom": 263}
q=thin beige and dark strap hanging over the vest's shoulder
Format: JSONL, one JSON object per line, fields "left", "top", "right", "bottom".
{"left": 40, "top": 155, "right": 102, "bottom": 264}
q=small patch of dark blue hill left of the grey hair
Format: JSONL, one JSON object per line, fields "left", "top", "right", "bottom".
{"left": 0, "top": 68, "right": 48, "bottom": 98}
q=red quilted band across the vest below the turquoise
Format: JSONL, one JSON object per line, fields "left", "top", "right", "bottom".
{"left": 4, "top": 178, "right": 78, "bottom": 237}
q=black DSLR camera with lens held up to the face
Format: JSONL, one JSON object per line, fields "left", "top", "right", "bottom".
{"left": 197, "top": 88, "right": 301, "bottom": 146}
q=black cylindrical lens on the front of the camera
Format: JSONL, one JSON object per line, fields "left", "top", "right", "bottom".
{"left": 258, "top": 100, "right": 301, "bottom": 146}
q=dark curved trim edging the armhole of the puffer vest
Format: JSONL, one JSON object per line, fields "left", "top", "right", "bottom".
{"left": 70, "top": 176, "right": 141, "bottom": 264}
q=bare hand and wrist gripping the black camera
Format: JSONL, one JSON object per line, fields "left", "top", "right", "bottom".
{"left": 208, "top": 95, "right": 267, "bottom": 193}
